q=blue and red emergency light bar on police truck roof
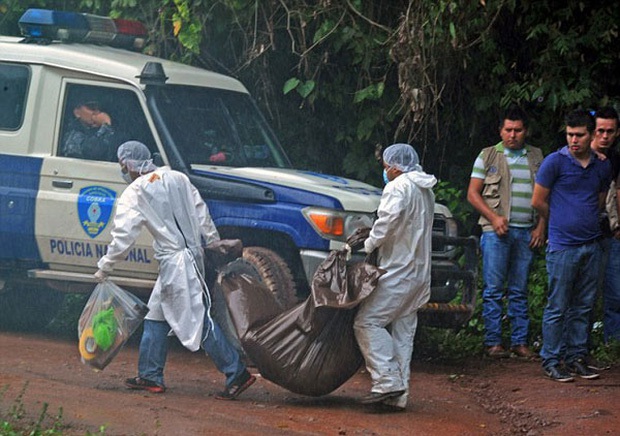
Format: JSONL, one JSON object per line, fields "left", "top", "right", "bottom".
{"left": 19, "top": 9, "right": 148, "bottom": 50}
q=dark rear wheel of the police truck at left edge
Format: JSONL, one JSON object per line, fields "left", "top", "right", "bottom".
{"left": 0, "top": 286, "right": 65, "bottom": 331}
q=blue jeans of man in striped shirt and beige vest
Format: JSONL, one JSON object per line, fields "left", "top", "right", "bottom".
{"left": 480, "top": 227, "right": 533, "bottom": 347}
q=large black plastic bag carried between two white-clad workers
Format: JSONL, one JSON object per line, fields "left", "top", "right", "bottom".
{"left": 219, "top": 250, "right": 384, "bottom": 396}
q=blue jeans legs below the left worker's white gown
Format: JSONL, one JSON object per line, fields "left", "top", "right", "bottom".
{"left": 138, "top": 315, "right": 246, "bottom": 387}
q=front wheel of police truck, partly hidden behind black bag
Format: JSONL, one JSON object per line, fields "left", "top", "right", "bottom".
{"left": 243, "top": 247, "right": 297, "bottom": 310}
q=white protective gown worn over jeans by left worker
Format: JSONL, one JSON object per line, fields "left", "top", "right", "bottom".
{"left": 97, "top": 168, "right": 219, "bottom": 351}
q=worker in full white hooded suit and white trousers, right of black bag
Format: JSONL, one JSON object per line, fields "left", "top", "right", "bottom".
{"left": 353, "top": 144, "right": 437, "bottom": 410}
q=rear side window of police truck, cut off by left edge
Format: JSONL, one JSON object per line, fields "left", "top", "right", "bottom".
{"left": 0, "top": 64, "right": 30, "bottom": 130}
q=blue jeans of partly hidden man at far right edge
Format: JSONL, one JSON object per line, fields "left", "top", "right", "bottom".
{"left": 603, "top": 238, "right": 620, "bottom": 342}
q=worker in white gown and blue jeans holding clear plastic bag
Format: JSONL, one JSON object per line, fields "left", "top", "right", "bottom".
{"left": 95, "top": 141, "right": 256, "bottom": 399}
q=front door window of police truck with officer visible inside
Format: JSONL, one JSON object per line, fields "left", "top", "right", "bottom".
{"left": 58, "top": 84, "right": 157, "bottom": 162}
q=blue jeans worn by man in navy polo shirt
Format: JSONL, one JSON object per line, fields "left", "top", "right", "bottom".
{"left": 540, "top": 242, "right": 602, "bottom": 368}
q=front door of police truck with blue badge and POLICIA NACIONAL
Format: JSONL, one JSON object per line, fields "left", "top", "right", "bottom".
{"left": 35, "top": 80, "right": 157, "bottom": 278}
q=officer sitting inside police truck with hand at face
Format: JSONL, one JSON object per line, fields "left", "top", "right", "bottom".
{"left": 60, "top": 101, "right": 119, "bottom": 162}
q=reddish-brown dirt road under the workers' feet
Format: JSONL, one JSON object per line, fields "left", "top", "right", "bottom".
{"left": 0, "top": 332, "right": 620, "bottom": 435}
